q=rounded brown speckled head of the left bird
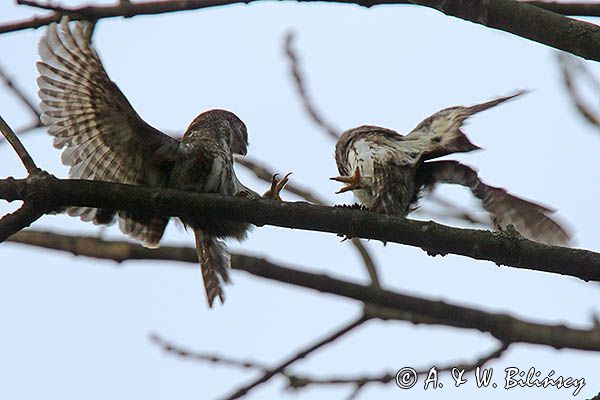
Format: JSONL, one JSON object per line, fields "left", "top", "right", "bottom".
{"left": 184, "top": 110, "right": 248, "bottom": 156}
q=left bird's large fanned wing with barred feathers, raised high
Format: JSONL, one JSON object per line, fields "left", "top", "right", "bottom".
{"left": 37, "top": 17, "right": 179, "bottom": 246}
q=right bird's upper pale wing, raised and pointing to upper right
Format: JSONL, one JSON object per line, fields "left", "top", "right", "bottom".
{"left": 402, "top": 91, "right": 526, "bottom": 160}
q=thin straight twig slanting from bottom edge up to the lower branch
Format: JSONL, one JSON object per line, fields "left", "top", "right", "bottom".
{"left": 221, "top": 315, "right": 369, "bottom": 400}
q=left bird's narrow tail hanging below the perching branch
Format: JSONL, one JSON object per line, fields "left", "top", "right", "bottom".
{"left": 194, "top": 229, "right": 231, "bottom": 307}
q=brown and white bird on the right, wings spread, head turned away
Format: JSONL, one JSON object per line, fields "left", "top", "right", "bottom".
{"left": 331, "top": 92, "right": 570, "bottom": 245}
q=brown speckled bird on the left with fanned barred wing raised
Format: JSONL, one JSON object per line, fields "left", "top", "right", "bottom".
{"left": 37, "top": 17, "right": 288, "bottom": 307}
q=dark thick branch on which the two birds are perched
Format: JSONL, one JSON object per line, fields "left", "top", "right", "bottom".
{"left": 0, "top": 176, "right": 600, "bottom": 281}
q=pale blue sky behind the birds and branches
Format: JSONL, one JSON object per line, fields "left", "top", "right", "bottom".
{"left": 0, "top": 1, "right": 600, "bottom": 400}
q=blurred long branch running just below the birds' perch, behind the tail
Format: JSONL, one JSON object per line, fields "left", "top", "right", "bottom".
{"left": 9, "top": 231, "right": 600, "bottom": 351}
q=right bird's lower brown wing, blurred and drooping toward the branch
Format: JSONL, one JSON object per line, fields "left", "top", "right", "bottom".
{"left": 417, "top": 161, "right": 571, "bottom": 245}
